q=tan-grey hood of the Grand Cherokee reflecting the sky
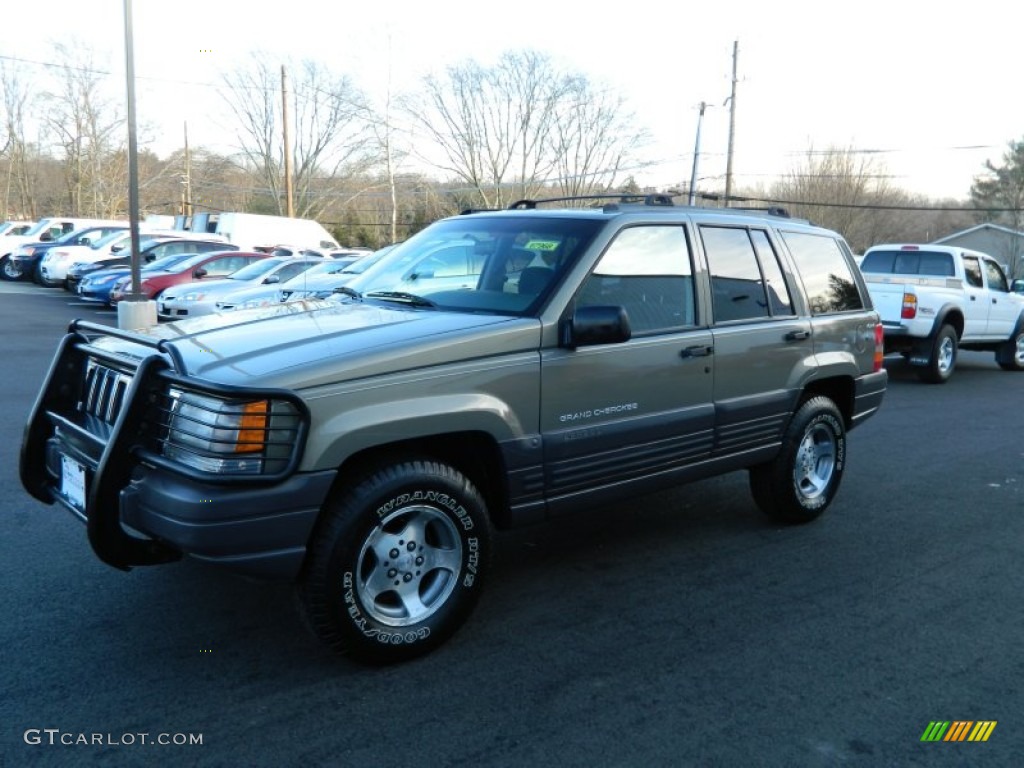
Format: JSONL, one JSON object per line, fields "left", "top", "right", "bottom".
{"left": 95, "top": 301, "right": 541, "bottom": 389}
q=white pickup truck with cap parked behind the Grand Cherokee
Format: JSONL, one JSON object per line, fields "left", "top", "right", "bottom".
{"left": 860, "top": 244, "right": 1024, "bottom": 384}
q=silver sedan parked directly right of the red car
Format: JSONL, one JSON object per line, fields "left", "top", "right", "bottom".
{"left": 157, "top": 257, "right": 323, "bottom": 319}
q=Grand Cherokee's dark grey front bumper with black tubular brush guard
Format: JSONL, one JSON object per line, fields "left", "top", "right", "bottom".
{"left": 19, "top": 322, "right": 319, "bottom": 579}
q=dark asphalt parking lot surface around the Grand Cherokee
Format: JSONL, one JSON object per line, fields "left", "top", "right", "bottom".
{"left": 0, "top": 284, "right": 1024, "bottom": 767}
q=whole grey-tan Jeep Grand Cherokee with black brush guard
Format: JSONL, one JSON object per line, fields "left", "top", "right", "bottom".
{"left": 20, "top": 196, "right": 887, "bottom": 664}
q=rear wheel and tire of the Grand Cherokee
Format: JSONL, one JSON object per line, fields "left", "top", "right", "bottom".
{"left": 750, "top": 396, "right": 846, "bottom": 523}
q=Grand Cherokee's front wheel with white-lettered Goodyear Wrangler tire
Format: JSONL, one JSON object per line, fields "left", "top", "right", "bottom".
{"left": 300, "top": 461, "right": 490, "bottom": 664}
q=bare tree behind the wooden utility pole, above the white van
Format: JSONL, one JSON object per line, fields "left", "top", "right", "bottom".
{"left": 222, "top": 53, "right": 372, "bottom": 218}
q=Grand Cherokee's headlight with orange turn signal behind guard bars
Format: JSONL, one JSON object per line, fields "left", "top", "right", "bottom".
{"left": 163, "top": 389, "right": 302, "bottom": 475}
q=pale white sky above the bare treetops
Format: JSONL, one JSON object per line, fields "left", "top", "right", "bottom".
{"left": 0, "top": 0, "right": 1024, "bottom": 199}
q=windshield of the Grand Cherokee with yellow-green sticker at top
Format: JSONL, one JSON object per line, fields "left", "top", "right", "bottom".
{"left": 348, "top": 213, "right": 603, "bottom": 314}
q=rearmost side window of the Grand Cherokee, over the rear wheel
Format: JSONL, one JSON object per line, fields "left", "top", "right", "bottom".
{"left": 781, "top": 231, "right": 866, "bottom": 314}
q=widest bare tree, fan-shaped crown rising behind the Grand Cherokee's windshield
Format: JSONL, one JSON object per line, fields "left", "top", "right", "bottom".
{"left": 403, "top": 50, "right": 642, "bottom": 208}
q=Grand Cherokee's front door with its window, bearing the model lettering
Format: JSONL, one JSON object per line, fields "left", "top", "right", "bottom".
{"left": 541, "top": 224, "right": 715, "bottom": 500}
